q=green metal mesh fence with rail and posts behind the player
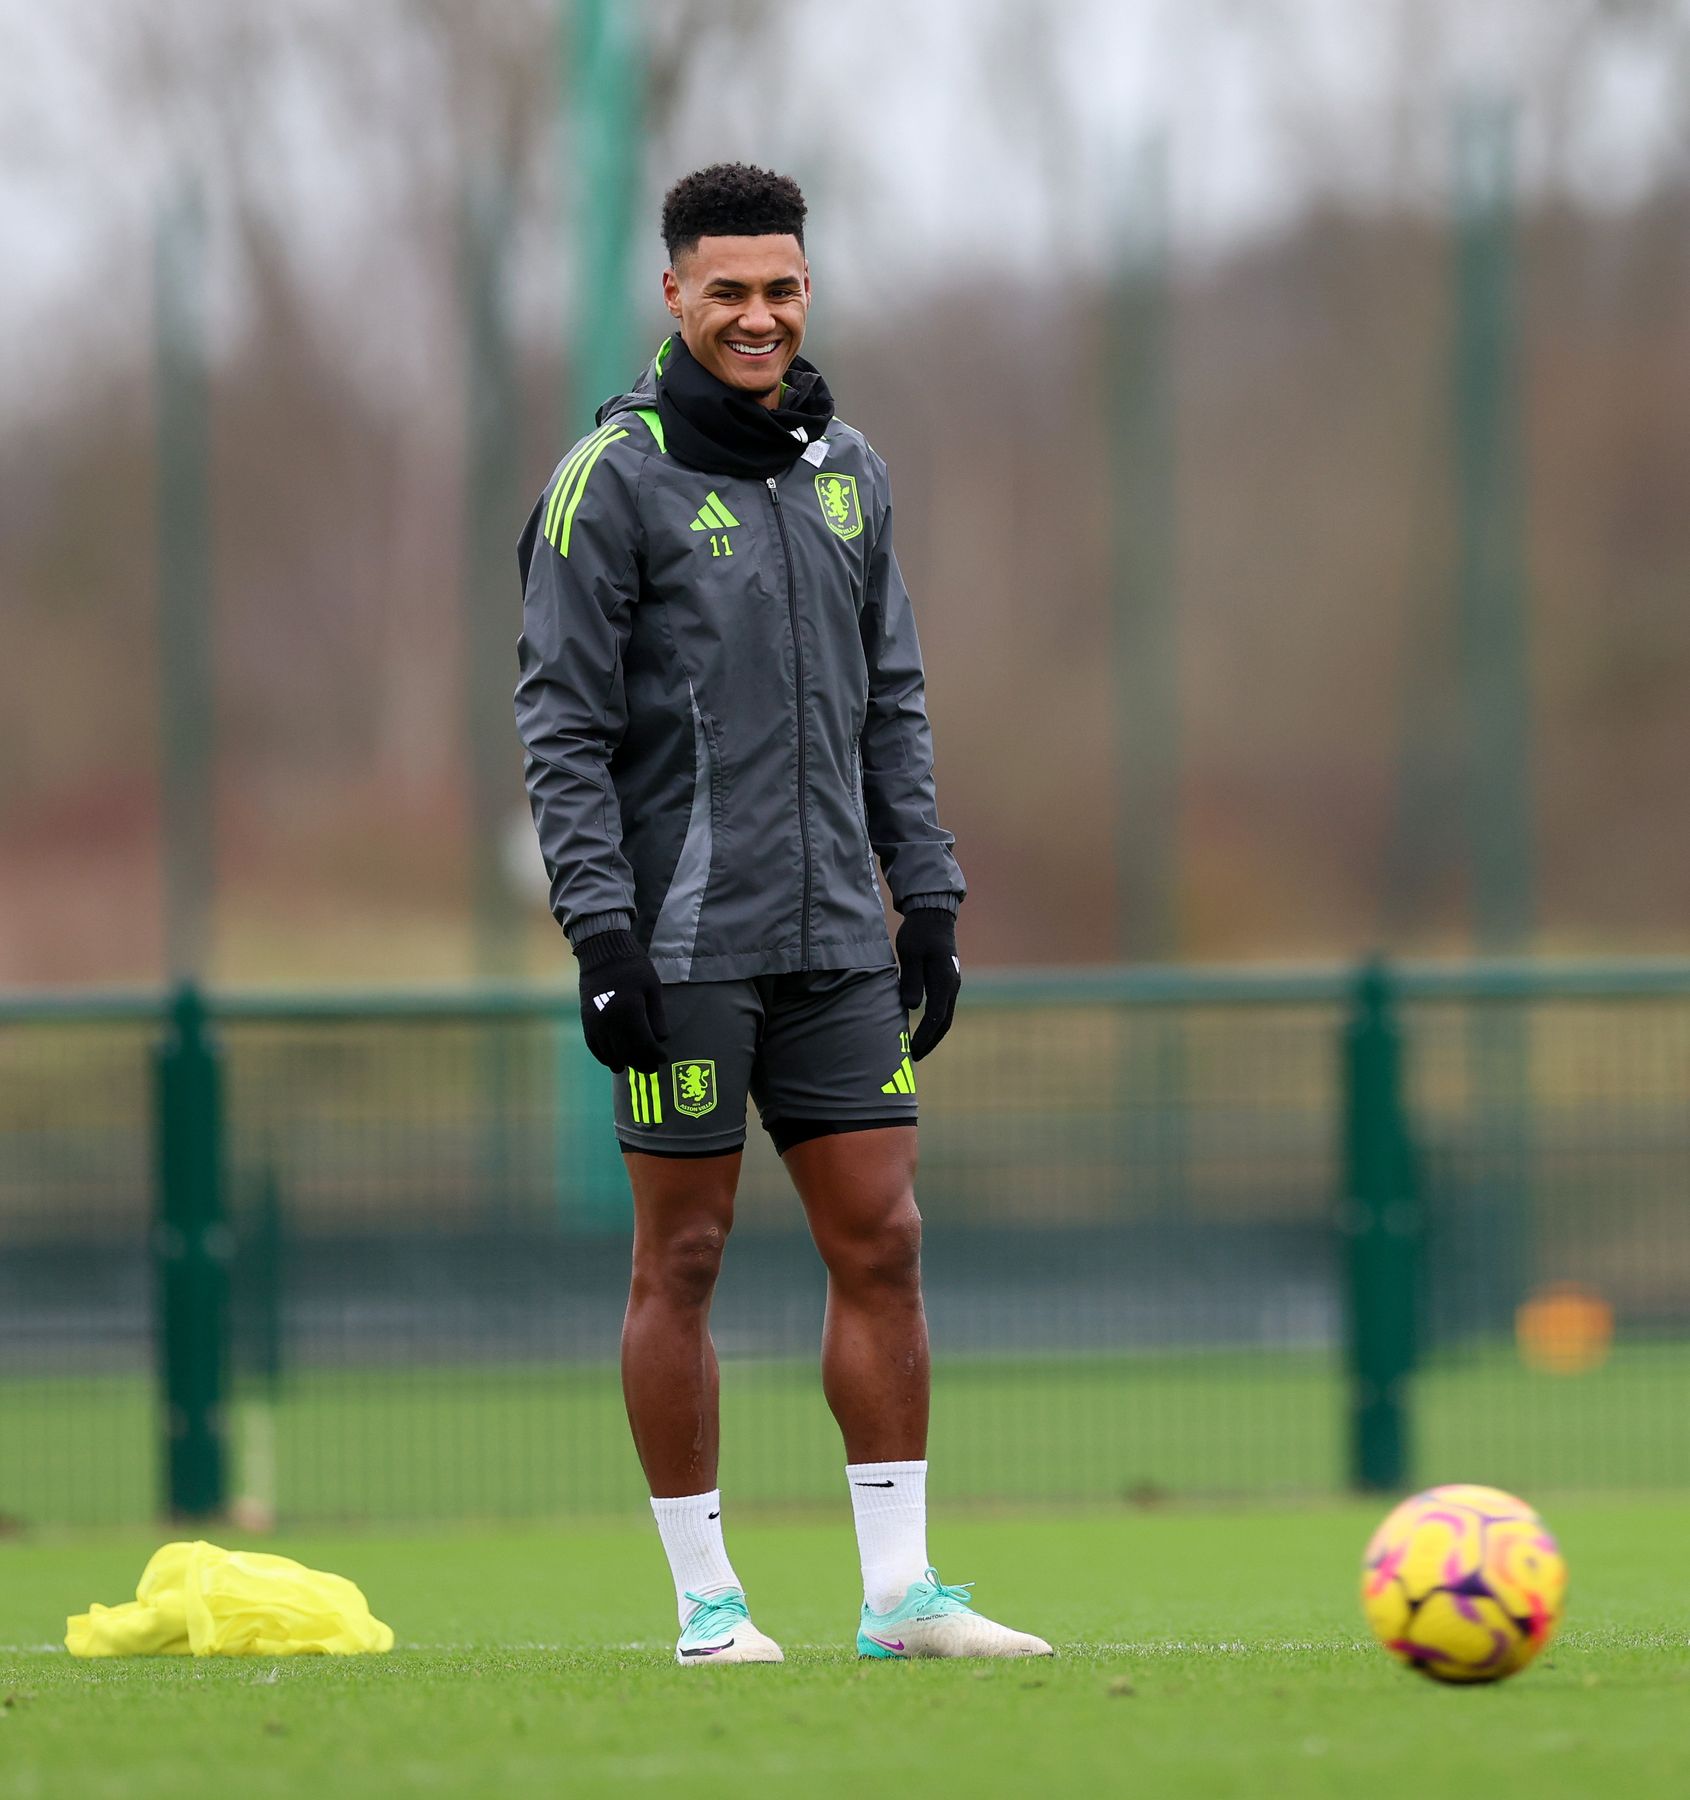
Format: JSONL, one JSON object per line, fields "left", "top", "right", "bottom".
{"left": 0, "top": 963, "right": 1690, "bottom": 1525}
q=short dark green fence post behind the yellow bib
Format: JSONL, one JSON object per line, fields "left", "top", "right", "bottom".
{"left": 153, "top": 983, "right": 229, "bottom": 1519}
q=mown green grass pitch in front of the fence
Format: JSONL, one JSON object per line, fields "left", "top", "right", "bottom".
{"left": 0, "top": 1499, "right": 1690, "bottom": 1800}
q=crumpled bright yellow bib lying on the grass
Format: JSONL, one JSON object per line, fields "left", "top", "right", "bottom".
{"left": 65, "top": 1541, "right": 392, "bottom": 1656}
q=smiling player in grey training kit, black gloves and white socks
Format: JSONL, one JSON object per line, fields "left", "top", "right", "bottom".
{"left": 517, "top": 164, "right": 1051, "bottom": 1665}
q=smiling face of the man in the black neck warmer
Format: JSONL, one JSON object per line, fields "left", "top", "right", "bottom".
{"left": 662, "top": 236, "right": 810, "bottom": 407}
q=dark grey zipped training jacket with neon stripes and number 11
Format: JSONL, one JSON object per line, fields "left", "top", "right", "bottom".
{"left": 517, "top": 342, "right": 966, "bottom": 981}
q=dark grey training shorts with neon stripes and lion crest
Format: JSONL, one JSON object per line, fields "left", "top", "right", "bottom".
{"left": 612, "top": 968, "right": 916, "bottom": 1156}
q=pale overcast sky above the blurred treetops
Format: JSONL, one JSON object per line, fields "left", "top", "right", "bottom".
{"left": 0, "top": 0, "right": 1690, "bottom": 408}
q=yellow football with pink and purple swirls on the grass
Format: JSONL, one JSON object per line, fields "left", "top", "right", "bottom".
{"left": 1361, "top": 1485, "right": 1566, "bottom": 1681}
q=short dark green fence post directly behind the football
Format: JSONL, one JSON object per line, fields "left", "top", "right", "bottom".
{"left": 1343, "top": 961, "right": 1420, "bottom": 1492}
